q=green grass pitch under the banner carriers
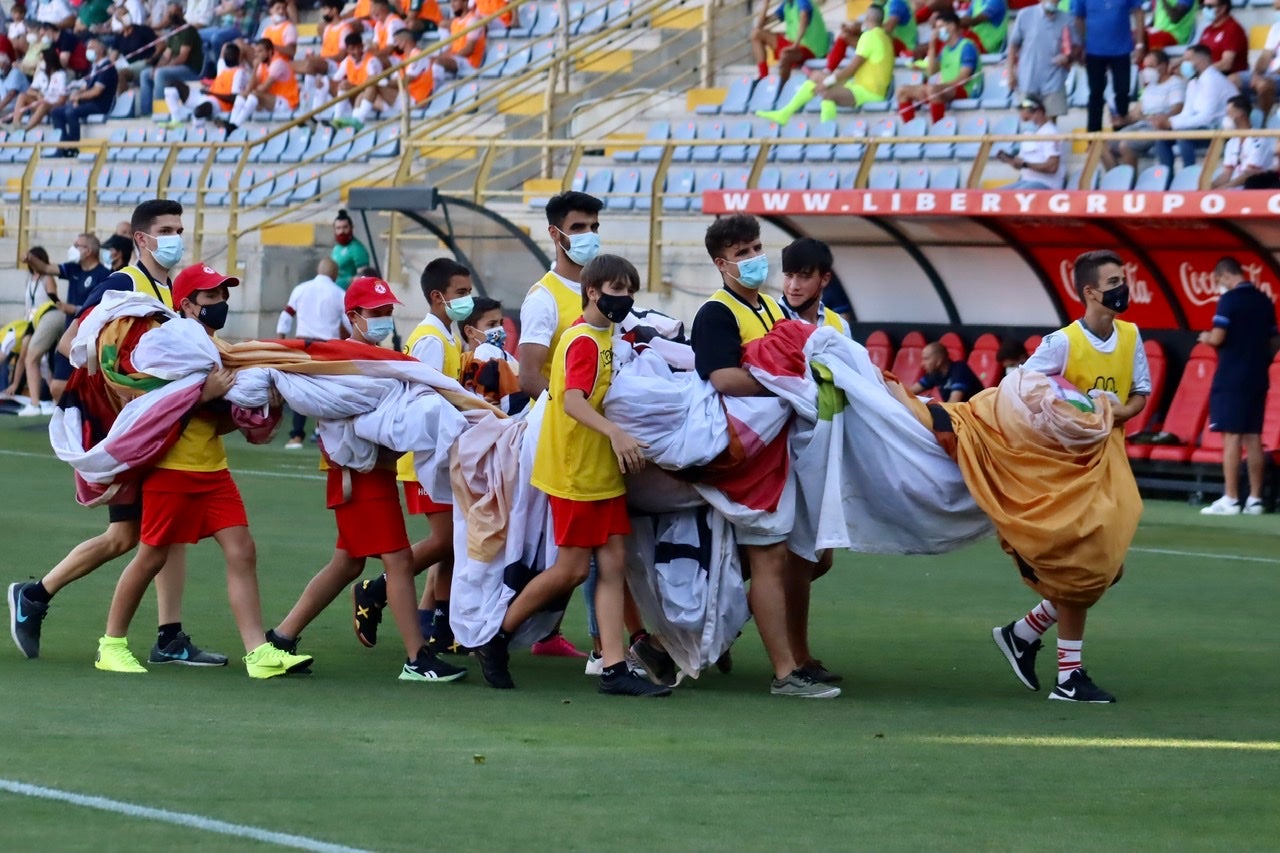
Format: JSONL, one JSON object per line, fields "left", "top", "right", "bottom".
{"left": 0, "top": 418, "right": 1280, "bottom": 850}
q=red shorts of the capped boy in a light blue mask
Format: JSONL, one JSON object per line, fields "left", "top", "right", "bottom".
{"left": 326, "top": 467, "right": 408, "bottom": 558}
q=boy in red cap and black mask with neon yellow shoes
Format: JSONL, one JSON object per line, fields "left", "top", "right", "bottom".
{"left": 93, "top": 264, "right": 311, "bottom": 679}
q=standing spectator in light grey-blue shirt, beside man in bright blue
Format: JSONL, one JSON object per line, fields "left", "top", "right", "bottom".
{"left": 1007, "top": 0, "right": 1080, "bottom": 119}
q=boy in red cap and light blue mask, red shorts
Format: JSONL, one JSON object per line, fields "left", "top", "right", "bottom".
{"left": 268, "top": 275, "right": 467, "bottom": 683}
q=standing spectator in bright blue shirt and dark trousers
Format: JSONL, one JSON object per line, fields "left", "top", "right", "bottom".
{"left": 1071, "top": 0, "right": 1146, "bottom": 133}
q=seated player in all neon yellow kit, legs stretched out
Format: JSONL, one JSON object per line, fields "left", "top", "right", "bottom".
{"left": 756, "top": 6, "right": 893, "bottom": 124}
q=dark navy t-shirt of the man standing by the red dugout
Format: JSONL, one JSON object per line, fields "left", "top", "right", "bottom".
{"left": 1213, "top": 284, "right": 1276, "bottom": 393}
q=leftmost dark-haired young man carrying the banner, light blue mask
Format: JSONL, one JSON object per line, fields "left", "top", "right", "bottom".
{"left": 9, "top": 199, "right": 218, "bottom": 666}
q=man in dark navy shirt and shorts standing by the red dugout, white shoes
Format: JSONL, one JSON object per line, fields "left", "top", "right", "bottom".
{"left": 1199, "top": 257, "right": 1280, "bottom": 515}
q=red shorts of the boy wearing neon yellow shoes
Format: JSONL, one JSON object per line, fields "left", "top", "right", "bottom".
{"left": 141, "top": 467, "right": 248, "bottom": 548}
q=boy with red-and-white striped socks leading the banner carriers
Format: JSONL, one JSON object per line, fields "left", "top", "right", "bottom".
{"left": 991, "top": 251, "right": 1151, "bottom": 703}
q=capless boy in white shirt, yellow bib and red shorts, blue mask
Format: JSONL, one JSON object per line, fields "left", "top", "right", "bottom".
{"left": 351, "top": 257, "right": 475, "bottom": 652}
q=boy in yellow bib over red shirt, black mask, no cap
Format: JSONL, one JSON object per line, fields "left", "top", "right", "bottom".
{"left": 476, "top": 255, "right": 671, "bottom": 695}
